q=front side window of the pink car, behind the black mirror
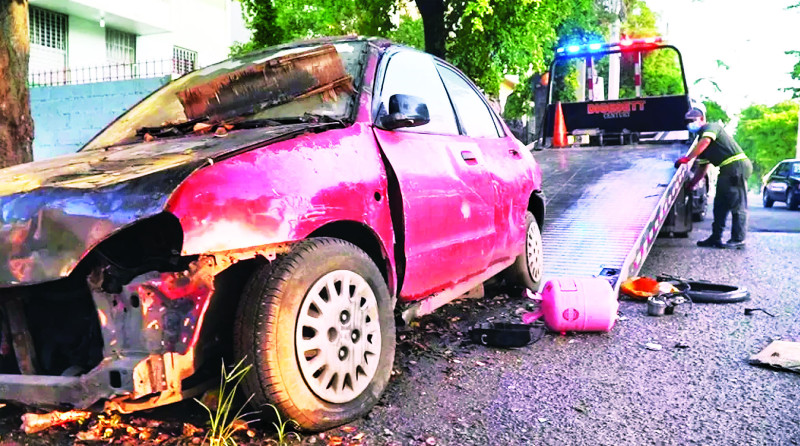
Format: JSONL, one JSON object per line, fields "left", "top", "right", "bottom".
{"left": 380, "top": 51, "right": 458, "bottom": 135}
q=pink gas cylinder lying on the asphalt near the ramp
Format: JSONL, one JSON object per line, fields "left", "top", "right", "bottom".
{"left": 523, "top": 277, "right": 619, "bottom": 334}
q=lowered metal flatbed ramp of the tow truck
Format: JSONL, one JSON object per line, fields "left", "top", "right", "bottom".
{"left": 534, "top": 143, "right": 688, "bottom": 286}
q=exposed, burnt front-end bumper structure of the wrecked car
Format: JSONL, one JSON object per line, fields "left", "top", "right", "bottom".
{"left": 0, "top": 244, "right": 289, "bottom": 413}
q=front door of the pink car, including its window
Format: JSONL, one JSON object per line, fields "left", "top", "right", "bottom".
{"left": 373, "top": 49, "right": 495, "bottom": 299}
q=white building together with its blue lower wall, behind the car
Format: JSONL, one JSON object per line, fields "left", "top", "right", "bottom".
{"left": 28, "top": 0, "right": 250, "bottom": 160}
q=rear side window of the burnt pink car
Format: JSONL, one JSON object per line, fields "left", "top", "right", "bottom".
{"left": 439, "top": 65, "right": 500, "bottom": 138}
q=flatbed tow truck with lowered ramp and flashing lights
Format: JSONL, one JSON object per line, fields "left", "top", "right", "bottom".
{"left": 534, "top": 38, "right": 708, "bottom": 291}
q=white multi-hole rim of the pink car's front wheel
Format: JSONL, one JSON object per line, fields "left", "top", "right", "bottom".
{"left": 295, "top": 270, "right": 381, "bottom": 403}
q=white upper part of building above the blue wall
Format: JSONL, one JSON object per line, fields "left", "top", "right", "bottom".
{"left": 29, "top": 0, "right": 249, "bottom": 86}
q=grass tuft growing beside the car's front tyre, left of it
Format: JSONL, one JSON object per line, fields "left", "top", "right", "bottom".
{"left": 195, "top": 359, "right": 252, "bottom": 446}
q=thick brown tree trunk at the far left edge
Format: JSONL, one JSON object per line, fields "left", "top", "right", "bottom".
{"left": 0, "top": 0, "right": 33, "bottom": 167}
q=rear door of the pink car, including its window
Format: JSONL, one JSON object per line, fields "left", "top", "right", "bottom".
{"left": 437, "top": 62, "right": 533, "bottom": 262}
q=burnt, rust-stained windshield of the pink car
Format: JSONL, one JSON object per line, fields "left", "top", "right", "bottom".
{"left": 82, "top": 42, "right": 365, "bottom": 150}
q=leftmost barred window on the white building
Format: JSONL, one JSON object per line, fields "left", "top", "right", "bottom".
{"left": 28, "top": 6, "right": 68, "bottom": 84}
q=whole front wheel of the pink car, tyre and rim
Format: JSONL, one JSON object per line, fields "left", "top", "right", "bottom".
{"left": 234, "top": 238, "right": 395, "bottom": 431}
